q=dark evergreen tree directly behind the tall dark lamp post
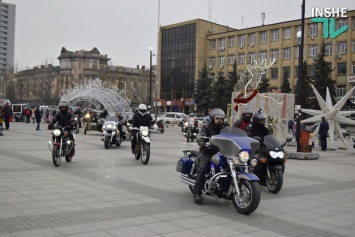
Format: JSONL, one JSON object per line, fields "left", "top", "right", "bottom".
{"left": 295, "top": 61, "right": 314, "bottom": 109}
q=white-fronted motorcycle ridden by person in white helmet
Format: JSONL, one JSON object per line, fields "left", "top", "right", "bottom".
{"left": 131, "top": 126, "right": 150, "bottom": 165}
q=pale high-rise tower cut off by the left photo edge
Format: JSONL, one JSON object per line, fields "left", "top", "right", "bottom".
{"left": 0, "top": 0, "right": 16, "bottom": 73}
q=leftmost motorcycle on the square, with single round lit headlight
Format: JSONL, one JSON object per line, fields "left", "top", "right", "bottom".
{"left": 48, "top": 119, "right": 75, "bottom": 167}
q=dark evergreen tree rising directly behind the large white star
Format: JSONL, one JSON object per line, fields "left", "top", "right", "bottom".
{"left": 312, "top": 43, "right": 336, "bottom": 103}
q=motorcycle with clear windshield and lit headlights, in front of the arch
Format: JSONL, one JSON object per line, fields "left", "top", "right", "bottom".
{"left": 101, "top": 114, "right": 124, "bottom": 149}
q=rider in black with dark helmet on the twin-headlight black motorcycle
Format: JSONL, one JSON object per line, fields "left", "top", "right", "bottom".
{"left": 246, "top": 110, "right": 271, "bottom": 141}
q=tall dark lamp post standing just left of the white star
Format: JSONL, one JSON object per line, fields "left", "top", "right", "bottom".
{"left": 296, "top": 0, "right": 305, "bottom": 152}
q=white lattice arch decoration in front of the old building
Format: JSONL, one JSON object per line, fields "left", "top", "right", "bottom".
{"left": 61, "top": 78, "right": 131, "bottom": 112}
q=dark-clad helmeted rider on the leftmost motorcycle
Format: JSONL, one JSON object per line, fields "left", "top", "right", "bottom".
{"left": 48, "top": 101, "right": 75, "bottom": 145}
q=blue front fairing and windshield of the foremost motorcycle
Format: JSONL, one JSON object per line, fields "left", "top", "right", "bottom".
{"left": 211, "top": 127, "right": 260, "bottom": 159}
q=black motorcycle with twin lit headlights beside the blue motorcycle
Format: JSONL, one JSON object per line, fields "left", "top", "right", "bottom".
{"left": 254, "top": 135, "right": 292, "bottom": 193}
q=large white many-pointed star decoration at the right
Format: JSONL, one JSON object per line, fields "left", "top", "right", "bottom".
{"left": 301, "top": 85, "right": 355, "bottom": 149}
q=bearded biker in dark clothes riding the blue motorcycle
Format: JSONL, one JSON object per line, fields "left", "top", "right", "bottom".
{"left": 194, "top": 108, "right": 225, "bottom": 204}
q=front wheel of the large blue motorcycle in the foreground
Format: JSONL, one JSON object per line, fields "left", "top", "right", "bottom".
{"left": 232, "top": 179, "right": 261, "bottom": 215}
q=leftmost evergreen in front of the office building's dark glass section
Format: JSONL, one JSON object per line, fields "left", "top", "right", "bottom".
{"left": 194, "top": 62, "right": 213, "bottom": 114}
